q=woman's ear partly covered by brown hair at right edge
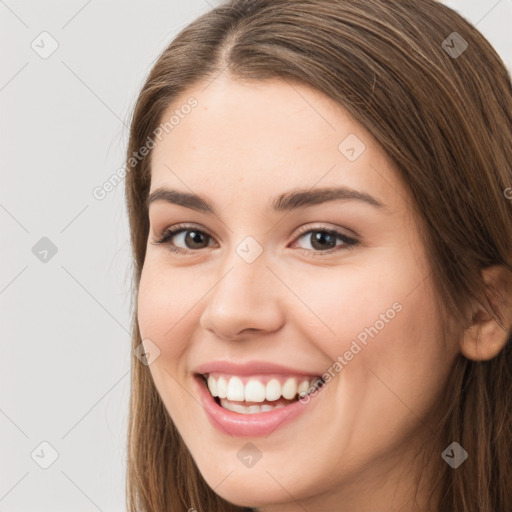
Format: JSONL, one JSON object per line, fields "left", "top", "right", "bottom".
{"left": 461, "top": 265, "right": 512, "bottom": 361}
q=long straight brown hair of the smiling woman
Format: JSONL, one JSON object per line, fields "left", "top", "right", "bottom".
{"left": 126, "top": 0, "right": 512, "bottom": 512}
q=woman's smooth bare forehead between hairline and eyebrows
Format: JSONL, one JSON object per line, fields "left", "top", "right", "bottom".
{"left": 151, "top": 75, "right": 406, "bottom": 214}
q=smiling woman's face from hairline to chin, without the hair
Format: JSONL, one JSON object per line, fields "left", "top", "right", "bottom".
{"left": 138, "top": 76, "right": 457, "bottom": 511}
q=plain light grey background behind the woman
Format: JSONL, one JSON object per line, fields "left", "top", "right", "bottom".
{"left": 0, "top": 0, "right": 512, "bottom": 512}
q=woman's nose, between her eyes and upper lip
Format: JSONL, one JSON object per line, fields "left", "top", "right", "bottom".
{"left": 199, "top": 248, "right": 284, "bottom": 340}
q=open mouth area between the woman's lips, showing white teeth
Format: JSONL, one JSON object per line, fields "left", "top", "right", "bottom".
{"left": 197, "top": 372, "right": 325, "bottom": 414}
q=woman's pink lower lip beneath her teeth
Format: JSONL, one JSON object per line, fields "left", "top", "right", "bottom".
{"left": 194, "top": 376, "right": 322, "bottom": 436}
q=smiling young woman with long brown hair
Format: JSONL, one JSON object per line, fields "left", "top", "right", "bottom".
{"left": 126, "top": 0, "right": 512, "bottom": 512}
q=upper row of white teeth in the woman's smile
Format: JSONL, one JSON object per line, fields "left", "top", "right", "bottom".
{"left": 204, "top": 375, "right": 316, "bottom": 402}
